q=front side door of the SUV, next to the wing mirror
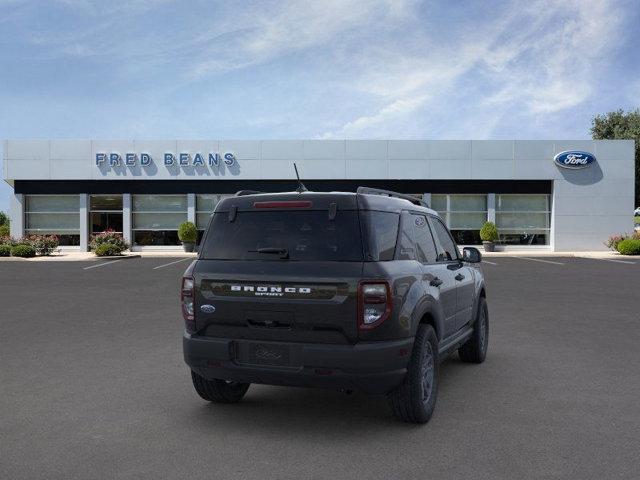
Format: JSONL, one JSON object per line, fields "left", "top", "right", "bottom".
{"left": 429, "top": 217, "right": 474, "bottom": 331}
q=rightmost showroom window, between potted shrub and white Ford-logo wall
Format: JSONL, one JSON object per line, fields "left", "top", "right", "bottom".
{"left": 496, "top": 194, "right": 551, "bottom": 245}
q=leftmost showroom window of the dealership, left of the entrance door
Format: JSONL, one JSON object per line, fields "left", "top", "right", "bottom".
{"left": 25, "top": 195, "right": 80, "bottom": 245}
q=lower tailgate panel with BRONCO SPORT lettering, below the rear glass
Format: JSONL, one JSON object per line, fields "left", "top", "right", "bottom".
{"left": 193, "top": 260, "right": 363, "bottom": 344}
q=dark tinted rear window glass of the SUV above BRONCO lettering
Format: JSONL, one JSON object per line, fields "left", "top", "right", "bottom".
{"left": 201, "top": 210, "right": 363, "bottom": 261}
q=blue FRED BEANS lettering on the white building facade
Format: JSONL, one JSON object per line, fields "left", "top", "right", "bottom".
{"left": 95, "top": 152, "right": 237, "bottom": 168}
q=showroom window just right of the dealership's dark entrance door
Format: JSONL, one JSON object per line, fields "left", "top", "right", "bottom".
{"left": 132, "top": 195, "right": 187, "bottom": 245}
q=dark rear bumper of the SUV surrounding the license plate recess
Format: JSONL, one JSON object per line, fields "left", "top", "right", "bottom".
{"left": 183, "top": 333, "right": 413, "bottom": 393}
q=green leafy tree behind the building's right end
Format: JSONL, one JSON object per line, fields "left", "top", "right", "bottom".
{"left": 591, "top": 109, "right": 640, "bottom": 206}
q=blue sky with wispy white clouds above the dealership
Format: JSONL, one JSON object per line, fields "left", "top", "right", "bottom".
{"left": 0, "top": 0, "right": 640, "bottom": 210}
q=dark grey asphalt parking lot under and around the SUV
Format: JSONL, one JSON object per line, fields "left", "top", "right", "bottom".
{"left": 0, "top": 257, "right": 640, "bottom": 480}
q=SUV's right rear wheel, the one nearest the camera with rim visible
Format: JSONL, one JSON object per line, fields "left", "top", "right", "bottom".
{"left": 387, "top": 325, "right": 438, "bottom": 423}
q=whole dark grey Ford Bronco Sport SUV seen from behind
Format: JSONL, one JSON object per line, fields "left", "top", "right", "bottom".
{"left": 181, "top": 187, "right": 489, "bottom": 423}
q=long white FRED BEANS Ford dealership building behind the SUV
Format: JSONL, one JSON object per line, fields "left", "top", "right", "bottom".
{"left": 3, "top": 139, "right": 634, "bottom": 251}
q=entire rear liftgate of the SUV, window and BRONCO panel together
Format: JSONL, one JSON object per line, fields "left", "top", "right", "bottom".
{"left": 194, "top": 202, "right": 363, "bottom": 343}
